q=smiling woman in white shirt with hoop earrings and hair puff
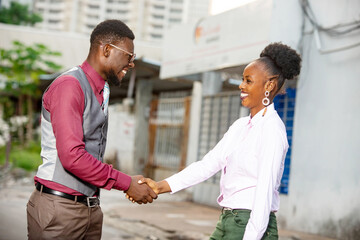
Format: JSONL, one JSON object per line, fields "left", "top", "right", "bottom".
{"left": 134, "top": 43, "right": 301, "bottom": 240}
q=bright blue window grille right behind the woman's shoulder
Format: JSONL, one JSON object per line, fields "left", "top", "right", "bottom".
{"left": 274, "top": 88, "right": 296, "bottom": 194}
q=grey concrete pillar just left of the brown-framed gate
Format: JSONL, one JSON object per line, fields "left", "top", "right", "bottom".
{"left": 134, "top": 79, "right": 153, "bottom": 174}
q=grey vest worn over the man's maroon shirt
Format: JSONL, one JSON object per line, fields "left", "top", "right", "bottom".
{"left": 36, "top": 67, "right": 108, "bottom": 196}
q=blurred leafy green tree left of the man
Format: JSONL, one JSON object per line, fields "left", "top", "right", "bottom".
{"left": 0, "top": 41, "right": 61, "bottom": 147}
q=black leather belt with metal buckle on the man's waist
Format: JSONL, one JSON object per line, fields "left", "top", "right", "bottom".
{"left": 36, "top": 183, "right": 100, "bottom": 207}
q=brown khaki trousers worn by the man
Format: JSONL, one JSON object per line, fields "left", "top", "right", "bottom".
{"left": 27, "top": 189, "right": 103, "bottom": 240}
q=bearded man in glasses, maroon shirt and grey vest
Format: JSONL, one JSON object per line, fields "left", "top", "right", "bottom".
{"left": 27, "top": 20, "right": 157, "bottom": 239}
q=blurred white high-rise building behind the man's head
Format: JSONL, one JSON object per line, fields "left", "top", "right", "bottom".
{"left": 34, "top": 0, "right": 211, "bottom": 42}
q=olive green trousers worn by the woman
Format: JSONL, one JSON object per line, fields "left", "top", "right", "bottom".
{"left": 210, "top": 209, "right": 279, "bottom": 240}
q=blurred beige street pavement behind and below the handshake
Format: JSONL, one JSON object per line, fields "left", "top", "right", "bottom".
{"left": 0, "top": 175, "right": 331, "bottom": 240}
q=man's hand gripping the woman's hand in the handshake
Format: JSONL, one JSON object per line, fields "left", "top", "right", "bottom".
{"left": 125, "top": 175, "right": 157, "bottom": 204}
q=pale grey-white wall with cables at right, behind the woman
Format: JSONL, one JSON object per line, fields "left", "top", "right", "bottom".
{"left": 271, "top": 0, "right": 360, "bottom": 239}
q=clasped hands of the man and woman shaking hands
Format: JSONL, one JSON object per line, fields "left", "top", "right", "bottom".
{"left": 125, "top": 175, "right": 171, "bottom": 204}
